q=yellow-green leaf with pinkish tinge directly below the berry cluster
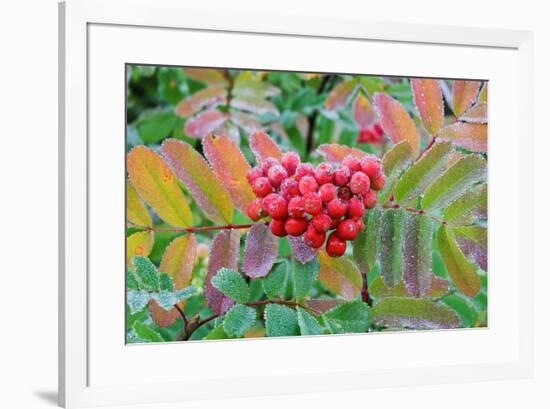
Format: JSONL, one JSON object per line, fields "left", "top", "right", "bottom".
{"left": 319, "top": 250, "right": 363, "bottom": 300}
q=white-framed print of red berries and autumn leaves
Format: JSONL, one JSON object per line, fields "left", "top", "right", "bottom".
{"left": 60, "top": 0, "right": 532, "bottom": 407}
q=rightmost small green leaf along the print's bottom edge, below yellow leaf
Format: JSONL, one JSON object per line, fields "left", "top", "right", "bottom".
{"left": 322, "top": 301, "right": 370, "bottom": 334}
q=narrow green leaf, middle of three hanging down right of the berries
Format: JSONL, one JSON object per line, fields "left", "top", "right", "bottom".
{"left": 379, "top": 208, "right": 405, "bottom": 287}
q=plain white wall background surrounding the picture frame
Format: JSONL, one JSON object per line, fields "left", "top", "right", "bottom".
{"left": 0, "top": 0, "right": 550, "bottom": 409}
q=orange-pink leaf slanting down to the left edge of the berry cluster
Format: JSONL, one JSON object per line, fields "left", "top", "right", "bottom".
{"left": 202, "top": 135, "right": 256, "bottom": 214}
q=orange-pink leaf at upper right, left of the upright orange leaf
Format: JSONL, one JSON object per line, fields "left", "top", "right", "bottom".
{"left": 373, "top": 93, "right": 420, "bottom": 158}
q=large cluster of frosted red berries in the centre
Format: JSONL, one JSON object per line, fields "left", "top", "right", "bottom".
{"left": 247, "top": 152, "right": 386, "bottom": 257}
